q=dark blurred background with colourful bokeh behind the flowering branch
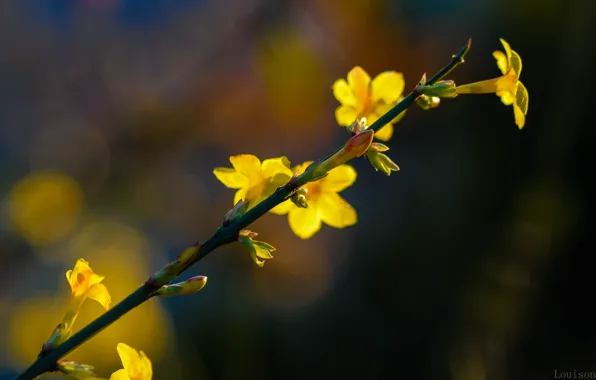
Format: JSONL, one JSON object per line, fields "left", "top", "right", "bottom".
{"left": 0, "top": 0, "right": 596, "bottom": 380}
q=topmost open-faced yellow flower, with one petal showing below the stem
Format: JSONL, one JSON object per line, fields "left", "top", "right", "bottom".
{"left": 333, "top": 66, "right": 405, "bottom": 141}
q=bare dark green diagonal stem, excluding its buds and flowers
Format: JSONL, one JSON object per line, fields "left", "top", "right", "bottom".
{"left": 16, "top": 41, "right": 470, "bottom": 380}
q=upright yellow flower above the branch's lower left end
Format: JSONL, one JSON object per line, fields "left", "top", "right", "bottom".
{"left": 66, "top": 259, "right": 112, "bottom": 310}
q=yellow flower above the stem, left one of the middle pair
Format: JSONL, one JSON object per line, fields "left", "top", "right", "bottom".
{"left": 213, "top": 154, "right": 292, "bottom": 208}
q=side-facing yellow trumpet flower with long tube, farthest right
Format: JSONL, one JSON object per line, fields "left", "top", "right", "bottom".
{"left": 457, "top": 38, "right": 529, "bottom": 129}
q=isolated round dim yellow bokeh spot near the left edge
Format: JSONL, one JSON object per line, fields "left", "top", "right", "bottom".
{"left": 9, "top": 171, "right": 84, "bottom": 246}
